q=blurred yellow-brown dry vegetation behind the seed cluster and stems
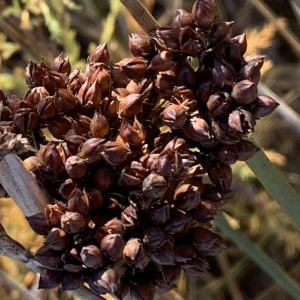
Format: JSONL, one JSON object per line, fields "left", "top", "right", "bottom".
{"left": 0, "top": 0, "right": 300, "bottom": 300}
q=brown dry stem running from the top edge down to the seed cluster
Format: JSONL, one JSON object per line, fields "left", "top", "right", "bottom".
{"left": 120, "top": 0, "right": 159, "bottom": 33}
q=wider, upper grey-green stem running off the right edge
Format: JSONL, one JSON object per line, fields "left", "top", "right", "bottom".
{"left": 246, "top": 139, "right": 300, "bottom": 231}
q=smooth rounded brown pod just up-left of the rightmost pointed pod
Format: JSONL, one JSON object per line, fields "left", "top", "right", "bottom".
{"left": 231, "top": 79, "right": 257, "bottom": 105}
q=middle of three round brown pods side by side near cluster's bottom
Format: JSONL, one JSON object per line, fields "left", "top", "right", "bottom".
{"left": 100, "top": 233, "right": 125, "bottom": 261}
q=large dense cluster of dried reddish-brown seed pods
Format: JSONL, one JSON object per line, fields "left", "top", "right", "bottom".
{"left": 0, "top": 0, "right": 277, "bottom": 300}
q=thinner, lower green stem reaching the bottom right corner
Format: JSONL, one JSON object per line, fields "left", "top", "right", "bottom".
{"left": 215, "top": 215, "right": 300, "bottom": 300}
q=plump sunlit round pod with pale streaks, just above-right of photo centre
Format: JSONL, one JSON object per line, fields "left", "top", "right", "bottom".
{"left": 163, "top": 104, "right": 187, "bottom": 130}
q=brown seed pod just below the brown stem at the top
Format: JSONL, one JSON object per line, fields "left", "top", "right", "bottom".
{"left": 129, "top": 33, "right": 156, "bottom": 59}
